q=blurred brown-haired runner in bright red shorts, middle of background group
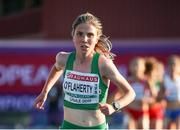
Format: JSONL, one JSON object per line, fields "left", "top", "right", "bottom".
{"left": 145, "top": 57, "right": 165, "bottom": 129}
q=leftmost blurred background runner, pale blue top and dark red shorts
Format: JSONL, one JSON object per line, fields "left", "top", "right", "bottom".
{"left": 126, "top": 57, "right": 149, "bottom": 129}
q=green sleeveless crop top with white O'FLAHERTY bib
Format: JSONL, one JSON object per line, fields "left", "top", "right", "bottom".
{"left": 63, "top": 52, "right": 108, "bottom": 110}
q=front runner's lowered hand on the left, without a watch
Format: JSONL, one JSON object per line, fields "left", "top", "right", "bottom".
{"left": 33, "top": 93, "right": 47, "bottom": 110}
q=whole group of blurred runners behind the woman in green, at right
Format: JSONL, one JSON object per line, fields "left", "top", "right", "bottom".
{"left": 107, "top": 55, "right": 180, "bottom": 129}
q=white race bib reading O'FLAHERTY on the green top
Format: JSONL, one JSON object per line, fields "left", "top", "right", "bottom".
{"left": 63, "top": 70, "right": 100, "bottom": 104}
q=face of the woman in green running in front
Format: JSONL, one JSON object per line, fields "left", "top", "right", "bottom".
{"left": 73, "top": 23, "right": 98, "bottom": 54}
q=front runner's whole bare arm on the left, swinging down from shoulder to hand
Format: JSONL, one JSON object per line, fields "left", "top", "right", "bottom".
{"left": 33, "top": 52, "right": 68, "bottom": 109}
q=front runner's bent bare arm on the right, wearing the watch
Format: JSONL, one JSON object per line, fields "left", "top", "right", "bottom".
{"left": 99, "top": 57, "right": 135, "bottom": 115}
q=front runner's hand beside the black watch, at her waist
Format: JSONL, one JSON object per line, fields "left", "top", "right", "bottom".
{"left": 99, "top": 103, "right": 115, "bottom": 116}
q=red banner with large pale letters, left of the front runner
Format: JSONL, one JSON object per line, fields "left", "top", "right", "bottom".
{"left": 0, "top": 53, "right": 54, "bottom": 94}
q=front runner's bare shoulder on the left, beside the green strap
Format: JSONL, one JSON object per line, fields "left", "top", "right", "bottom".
{"left": 55, "top": 51, "right": 70, "bottom": 69}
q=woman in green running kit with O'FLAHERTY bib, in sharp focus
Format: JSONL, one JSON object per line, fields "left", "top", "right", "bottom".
{"left": 34, "top": 13, "right": 135, "bottom": 129}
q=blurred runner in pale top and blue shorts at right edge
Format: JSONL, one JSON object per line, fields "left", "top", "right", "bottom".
{"left": 164, "top": 55, "right": 180, "bottom": 129}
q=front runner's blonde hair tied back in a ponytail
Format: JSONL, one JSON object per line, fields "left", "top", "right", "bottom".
{"left": 71, "top": 13, "right": 115, "bottom": 59}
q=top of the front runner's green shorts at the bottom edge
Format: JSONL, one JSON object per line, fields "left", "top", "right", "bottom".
{"left": 60, "top": 120, "right": 107, "bottom": 130}
